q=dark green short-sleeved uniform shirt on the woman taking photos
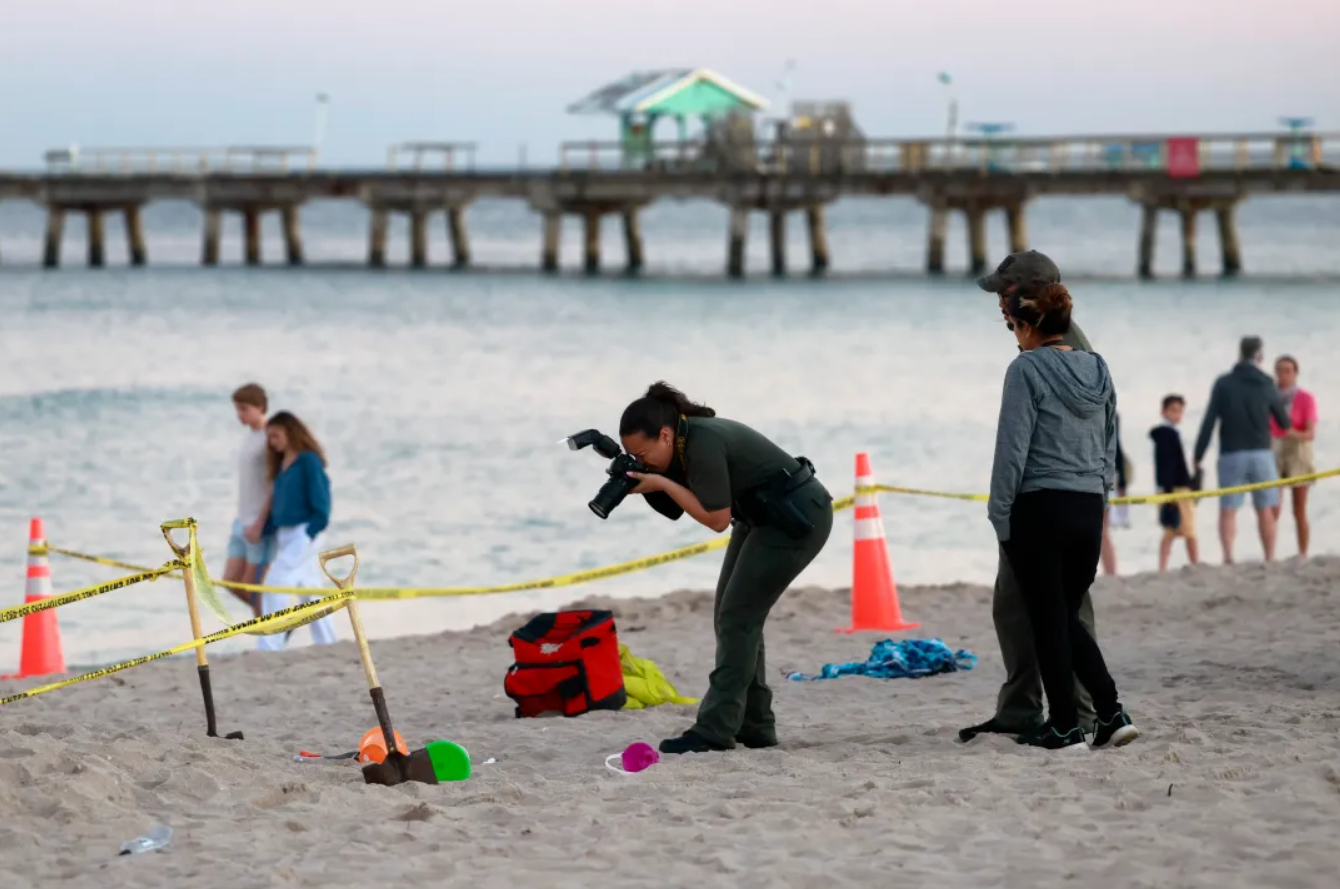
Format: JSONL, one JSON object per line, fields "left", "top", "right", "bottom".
{"left": 646, "top": 417, "right": 800, "bottom": 519}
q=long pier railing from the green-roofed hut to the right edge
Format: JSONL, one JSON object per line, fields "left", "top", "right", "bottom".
{"left": 559, "top": 133, "right": 1340, "bottom": 174}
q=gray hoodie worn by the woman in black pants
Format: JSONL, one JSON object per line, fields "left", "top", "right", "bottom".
{"left": 986, "top": 347, "right": 1116, "bottom": 542}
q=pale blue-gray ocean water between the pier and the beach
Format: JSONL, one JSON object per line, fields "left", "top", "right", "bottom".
{"left": 0, "top": 198, "right": 1340, "bottom": 666}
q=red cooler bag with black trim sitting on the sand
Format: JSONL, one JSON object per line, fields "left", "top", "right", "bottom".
{"left": 503, "top": 611, "right": 628, "bottom": 717}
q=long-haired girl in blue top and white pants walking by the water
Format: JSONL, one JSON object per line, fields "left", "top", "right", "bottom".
{"left": 257, "top": 410, "right": 335, "bottom": 652}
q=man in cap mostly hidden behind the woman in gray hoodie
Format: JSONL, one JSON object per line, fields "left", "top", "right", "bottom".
{"left": 958, "top": 249, "right": 1097, "bottom": 742}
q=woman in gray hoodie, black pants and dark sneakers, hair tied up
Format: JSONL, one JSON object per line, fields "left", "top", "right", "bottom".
{"left": 986, "top": 282, "right": 1139, "bottom": 750}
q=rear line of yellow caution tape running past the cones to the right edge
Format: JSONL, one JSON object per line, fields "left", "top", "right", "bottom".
{"left": 31, "top": 469, "right": 1340, "bottom": 601}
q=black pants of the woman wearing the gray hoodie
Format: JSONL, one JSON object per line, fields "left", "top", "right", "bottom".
{"left": 1002, "top": 491, "right": 1120, "bottom": 732}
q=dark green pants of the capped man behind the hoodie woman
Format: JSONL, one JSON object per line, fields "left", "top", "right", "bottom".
{"left": 992, "top": 550, "right": 1097, "bottom": 732}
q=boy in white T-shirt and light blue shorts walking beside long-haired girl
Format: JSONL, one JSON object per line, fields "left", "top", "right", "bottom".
{"left": 224, "top": 382, "right": 273, "bottom": 617}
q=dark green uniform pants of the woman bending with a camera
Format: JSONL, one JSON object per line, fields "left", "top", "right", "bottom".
{"left": 693, "top": 481, "right": 833, "bottom": 747}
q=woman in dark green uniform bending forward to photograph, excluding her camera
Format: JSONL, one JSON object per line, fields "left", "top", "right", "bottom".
{"left": 619, "top": 382, "right": 833, "bottom": 754}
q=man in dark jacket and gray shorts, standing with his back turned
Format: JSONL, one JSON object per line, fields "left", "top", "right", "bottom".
{"left": 1195, "top": 337, "right": 1292, "bottom": 565}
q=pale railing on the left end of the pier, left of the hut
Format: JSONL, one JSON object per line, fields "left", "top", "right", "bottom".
{"left": 43, "top": 145, "right": 318, "bottom": 176}
